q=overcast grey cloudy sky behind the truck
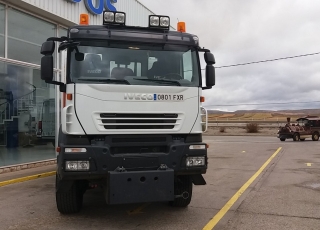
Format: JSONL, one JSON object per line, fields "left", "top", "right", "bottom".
{"left": 139, "top": 0, "right": 320, "bottom": 111}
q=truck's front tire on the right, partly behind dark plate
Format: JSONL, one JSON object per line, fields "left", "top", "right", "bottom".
{"left": 169, "top": 176, "right": 193, "bottom": 207}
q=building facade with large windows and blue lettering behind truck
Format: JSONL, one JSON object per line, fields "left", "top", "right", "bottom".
{"left": 0, "top": 0, "right": 160, "bottom": 168}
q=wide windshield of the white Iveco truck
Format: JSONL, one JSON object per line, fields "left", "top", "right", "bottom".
{"left": 69, "top": 42, "right": 200, "bottom": 87}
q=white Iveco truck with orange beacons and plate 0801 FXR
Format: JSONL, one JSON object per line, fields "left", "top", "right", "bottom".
{"left": 41, "top": 11, "right": 215, "bottom": 214}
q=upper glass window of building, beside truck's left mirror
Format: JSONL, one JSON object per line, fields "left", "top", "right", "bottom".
{"left": 8, "top": 9, "right": 56, "bottom": 65}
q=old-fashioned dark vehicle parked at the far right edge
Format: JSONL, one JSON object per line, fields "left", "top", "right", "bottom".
{"left": 277, "top": 116, "right": 320, "bottom": 141}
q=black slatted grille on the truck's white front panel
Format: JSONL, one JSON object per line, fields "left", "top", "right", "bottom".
{"left": 98, "top": 113, "right": 181, "bottom": 130}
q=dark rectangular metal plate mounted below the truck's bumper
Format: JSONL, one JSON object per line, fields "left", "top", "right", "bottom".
{"left": 105, "top": 169, "right": 174, "bottom": 204}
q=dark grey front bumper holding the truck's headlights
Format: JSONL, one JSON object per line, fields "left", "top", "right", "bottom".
{"left": 57, "top": 143, "right": 208, "bottom": 180}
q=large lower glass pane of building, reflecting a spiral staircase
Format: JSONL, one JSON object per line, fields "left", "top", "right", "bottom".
{"left": 0, "top": 62, "right": 55, "bottom": 167}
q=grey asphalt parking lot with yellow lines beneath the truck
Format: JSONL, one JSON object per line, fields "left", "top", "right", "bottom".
{"left": 0, "top": 136, "right": 320, "bottom": 230}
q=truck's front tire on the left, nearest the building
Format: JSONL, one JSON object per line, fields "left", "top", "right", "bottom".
{"left": 56, "top": 176, "right": 83, "bottom": 214}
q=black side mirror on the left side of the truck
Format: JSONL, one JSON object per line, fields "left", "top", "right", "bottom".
{"left": 40, "top": 41, "right": 55, "bottom": 83}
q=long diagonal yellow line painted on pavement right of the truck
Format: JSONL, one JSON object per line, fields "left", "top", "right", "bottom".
{"left": 203, "top": 147, "right": 282, "bottom": 230}
